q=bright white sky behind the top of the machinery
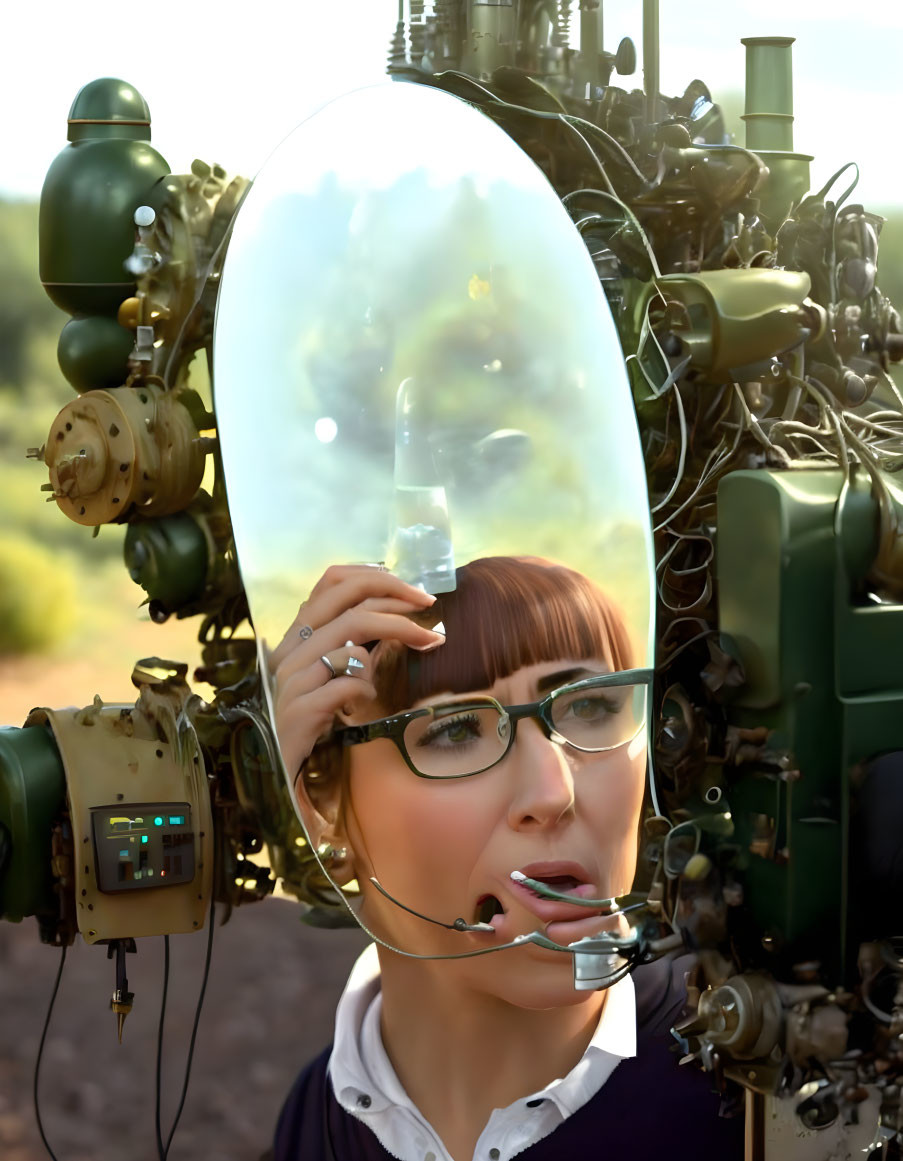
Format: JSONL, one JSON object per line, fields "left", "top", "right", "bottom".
{"left": 0, "top": 0, "right": 903, "bottom": 208}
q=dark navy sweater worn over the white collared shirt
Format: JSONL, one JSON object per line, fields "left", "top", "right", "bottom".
{"left": 268, "top": 960, "right": 744, "bottom": 1161}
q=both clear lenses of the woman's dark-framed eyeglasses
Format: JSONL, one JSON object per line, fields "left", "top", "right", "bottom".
{"left": 404, "top": 685, "right": 645, "bottom": 778}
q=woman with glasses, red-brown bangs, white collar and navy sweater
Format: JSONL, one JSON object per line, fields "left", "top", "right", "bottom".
{"left": 263, "top": 557, "right": 743, "bottom": 1161}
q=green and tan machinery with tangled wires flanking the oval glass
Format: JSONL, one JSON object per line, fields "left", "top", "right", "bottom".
{"left": 0, "top": 0, "right": 903, "bottom": 1156}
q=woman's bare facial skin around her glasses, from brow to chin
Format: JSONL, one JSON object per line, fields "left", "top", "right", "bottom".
{"left": 345, "top": 658, "right": 646, "bottom": 1007}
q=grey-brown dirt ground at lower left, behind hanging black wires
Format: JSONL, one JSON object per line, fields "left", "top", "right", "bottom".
{"left": 0, "top": 900, "right": 364, "bottom": 1161}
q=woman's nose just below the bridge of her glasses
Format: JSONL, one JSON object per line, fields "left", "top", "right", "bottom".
{"left": 508, "top": 720, "right": 575, "bottom": 830}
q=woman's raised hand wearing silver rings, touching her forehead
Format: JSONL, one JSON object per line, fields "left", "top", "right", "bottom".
{"left": 269, "top": 564, "right": 445, "bottom": 777}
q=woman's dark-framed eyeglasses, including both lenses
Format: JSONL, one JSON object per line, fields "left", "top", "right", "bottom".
{"left": 334, "top": 669, "right": 653, "bottom": 778}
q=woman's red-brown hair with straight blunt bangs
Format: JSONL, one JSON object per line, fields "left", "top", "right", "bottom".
{"left": 374, "top": 556, "right": 633, "bottom": 714}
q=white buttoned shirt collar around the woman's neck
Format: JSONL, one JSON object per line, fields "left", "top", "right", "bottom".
{"left": 328, "top": 944, "right": 636, "bottom": 1161}
